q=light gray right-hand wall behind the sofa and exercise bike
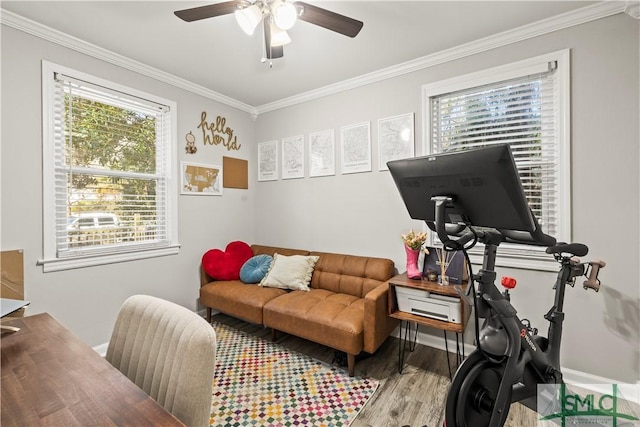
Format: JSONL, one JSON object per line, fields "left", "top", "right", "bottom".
{"left": 256, "top": 14, "right": 640, "bottom": 383}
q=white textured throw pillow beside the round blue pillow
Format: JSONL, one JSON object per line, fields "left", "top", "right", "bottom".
{"left": 260, "top": 253, "right": 320, "bottom": 291}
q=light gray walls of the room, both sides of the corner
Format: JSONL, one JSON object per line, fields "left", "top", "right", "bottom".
{"left": 1, "top": 14, "right": 640, "bottom": 383}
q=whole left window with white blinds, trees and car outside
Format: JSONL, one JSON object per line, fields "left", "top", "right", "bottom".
{"left": 41, "top": 62, "right": 178, "bottom": 272}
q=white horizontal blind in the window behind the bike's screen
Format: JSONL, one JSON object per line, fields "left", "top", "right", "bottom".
{"left": 431, "top": 65, "right": 559, "bottom": 236}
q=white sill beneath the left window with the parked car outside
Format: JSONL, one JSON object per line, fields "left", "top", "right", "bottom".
{"left": 38, "top": 244, "right": 180, "bottom": 273}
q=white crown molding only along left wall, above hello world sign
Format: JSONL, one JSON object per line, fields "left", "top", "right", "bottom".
{"left": 0, "top": 9, "right": 255, "bottom": 114}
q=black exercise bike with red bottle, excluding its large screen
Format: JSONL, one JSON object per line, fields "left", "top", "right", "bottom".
{"left": 435, "top": 198, "right": 605, "bottom": 427}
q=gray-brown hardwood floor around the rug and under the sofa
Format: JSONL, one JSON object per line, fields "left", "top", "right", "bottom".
{"left": 213, "top": 314, "right": 537, "bottom": 427}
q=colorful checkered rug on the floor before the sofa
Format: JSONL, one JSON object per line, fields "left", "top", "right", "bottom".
{"left": 210, "top": 323, "right": 378, "bottom": 427}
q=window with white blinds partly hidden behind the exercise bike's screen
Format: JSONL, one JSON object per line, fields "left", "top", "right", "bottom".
{"left": 423, "top": 51, "right": 571, "bottom": 269}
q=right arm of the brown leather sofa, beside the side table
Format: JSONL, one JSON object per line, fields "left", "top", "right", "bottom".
{"left": 364, "top": 282, "right": 399, "bottom": 353}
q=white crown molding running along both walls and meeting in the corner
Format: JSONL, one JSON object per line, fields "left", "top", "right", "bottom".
{"left": 0, "top": 1, "right": 628, "bottom": 120}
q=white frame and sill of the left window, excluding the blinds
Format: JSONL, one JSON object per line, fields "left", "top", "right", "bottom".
{"left": 38, "top": 60, "right": 180, "bottom": 273}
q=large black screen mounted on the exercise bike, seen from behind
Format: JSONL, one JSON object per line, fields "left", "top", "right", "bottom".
{"left": 387, "top": 144, "right": 537, "bottom": 232}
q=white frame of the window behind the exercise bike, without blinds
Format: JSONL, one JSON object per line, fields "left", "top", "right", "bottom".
{"left": 422, "top": 49, "right": 571, "bottom": 271}
